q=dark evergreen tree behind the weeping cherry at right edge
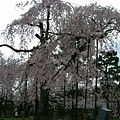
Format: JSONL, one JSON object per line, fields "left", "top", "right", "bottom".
{"left": 98, "top": 50, "right": 120, "bottom": 115}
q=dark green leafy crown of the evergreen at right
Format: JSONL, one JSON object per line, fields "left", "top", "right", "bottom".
{"left": 98, "top": 50, "right": 120, "bottom": 82}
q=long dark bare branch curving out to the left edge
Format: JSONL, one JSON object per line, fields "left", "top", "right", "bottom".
{"left": 0, "top": 44, "right": 38, "bottom": 52}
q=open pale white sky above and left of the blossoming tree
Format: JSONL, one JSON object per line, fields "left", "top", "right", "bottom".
{"left": 0, "top": 0, "right": 120, "bottom": 55}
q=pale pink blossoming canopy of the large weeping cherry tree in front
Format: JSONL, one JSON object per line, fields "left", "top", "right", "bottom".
{"left": 0, "top": 0, "right": 120, "bottom": 119}
